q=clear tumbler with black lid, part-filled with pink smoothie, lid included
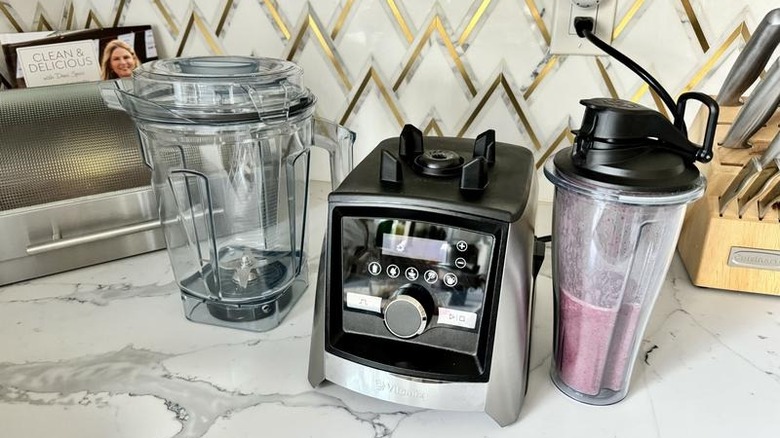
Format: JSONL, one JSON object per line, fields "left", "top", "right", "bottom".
{"left": 544, "top": 93, "right": 718, "bottom": 405}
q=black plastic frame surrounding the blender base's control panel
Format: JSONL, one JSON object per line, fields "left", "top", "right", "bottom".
{"left": 325, "top": 204, "right": 509, "bottom": 382}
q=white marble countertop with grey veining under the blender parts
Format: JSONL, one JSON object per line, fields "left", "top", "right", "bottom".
{"left": 0, "top": 184, "right": 780, "bottom": 438}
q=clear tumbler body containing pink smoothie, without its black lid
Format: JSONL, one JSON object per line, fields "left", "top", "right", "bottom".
{"left": 545, "top": 160, "right": 704, "bottom": 405}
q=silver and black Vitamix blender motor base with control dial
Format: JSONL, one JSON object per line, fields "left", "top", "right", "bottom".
{"left": 309, "top": 125, "right": 543, "bottom": 425}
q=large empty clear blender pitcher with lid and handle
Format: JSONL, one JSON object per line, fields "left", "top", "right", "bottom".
{"left": 103, "top": 56, "right": 354, "bottom": 331}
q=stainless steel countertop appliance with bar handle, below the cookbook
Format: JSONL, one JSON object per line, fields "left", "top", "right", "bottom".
{"left": 0, "top": 83, "right": 165, "bottom": 285}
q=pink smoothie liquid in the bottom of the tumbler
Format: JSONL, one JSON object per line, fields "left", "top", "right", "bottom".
{"left": 556, "top": 290, "right": 640, "bottom": 395}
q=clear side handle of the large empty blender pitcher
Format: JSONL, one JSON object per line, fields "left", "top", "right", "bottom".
{"left": 314, "top": 117, "right": 355, "bottom": 189}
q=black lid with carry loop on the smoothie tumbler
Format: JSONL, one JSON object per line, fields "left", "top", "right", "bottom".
{"left": 553, "top": 96, "right": 717, "bottom": 194}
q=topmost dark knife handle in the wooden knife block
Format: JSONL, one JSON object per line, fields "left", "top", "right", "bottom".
{"left": 717, "top": 8, "right": 780, "bottom": 106}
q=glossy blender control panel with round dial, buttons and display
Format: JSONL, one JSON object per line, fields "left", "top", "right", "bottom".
{"left": 341, "top": 217, "right": 495, "bottom": 354}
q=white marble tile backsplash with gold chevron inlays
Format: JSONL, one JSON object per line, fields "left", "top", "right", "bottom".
{"left": 0, "top": 0, "right": 778, "bottom": 200}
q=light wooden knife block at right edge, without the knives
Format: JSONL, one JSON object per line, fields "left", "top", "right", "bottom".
{"left": 677, "top": 101, "right": 780, "bottom": 296}
